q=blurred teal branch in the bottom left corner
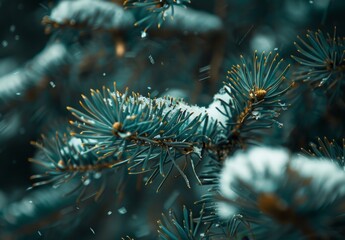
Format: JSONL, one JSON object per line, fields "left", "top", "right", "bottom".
{"left": 0, "top": 183, "right": 75, "bottom": 239}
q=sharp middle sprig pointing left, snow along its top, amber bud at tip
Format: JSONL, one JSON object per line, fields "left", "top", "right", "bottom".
{"left": 64, "top": 85, "right": 214, "bottom": 190}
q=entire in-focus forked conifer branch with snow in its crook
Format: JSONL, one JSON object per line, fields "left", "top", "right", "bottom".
{"left": 30, "top": 50, "right": 290, "bottom": 199}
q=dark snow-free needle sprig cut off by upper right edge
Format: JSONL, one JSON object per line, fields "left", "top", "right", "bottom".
{"left": 291, "top": 27, "right": 345, "bottom": 97}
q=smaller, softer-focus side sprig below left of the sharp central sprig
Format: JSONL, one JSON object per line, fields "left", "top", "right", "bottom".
{"left": 29, "top": 128, "right": 121, "bottom": 202}
